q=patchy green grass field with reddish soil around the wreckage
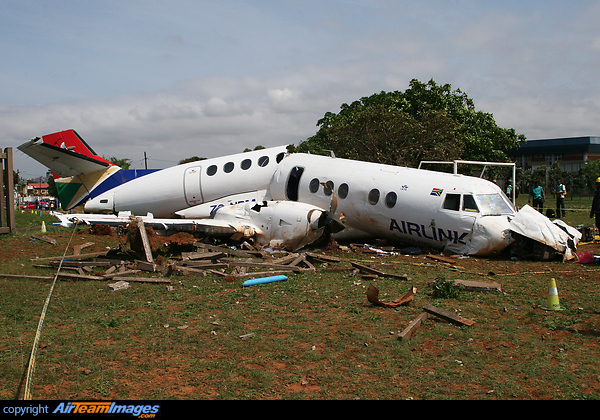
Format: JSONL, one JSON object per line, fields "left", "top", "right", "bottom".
{"left": 0, "top": 207, "right": 600, "bottom": 400}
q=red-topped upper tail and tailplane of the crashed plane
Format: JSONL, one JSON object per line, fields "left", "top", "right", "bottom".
{"left": 17, "top": 130, "right": 113, "bottom": 177}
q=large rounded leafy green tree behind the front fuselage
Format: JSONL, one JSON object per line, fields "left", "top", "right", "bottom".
{"left": 298, "top": 79, "right": 525, "bottom": 166}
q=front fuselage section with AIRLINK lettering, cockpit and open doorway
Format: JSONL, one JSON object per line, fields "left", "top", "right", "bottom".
{"left": 269, "top": 154, "right": 516, "bottom": 254}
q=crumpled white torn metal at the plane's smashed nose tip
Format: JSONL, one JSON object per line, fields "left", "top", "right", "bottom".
{"left": 510, "top": 205, "right": 581, "bottom": 260}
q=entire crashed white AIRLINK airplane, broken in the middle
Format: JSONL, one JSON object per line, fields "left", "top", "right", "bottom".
{"left": 18, "top": 130, "right": 581, "bottom": 259}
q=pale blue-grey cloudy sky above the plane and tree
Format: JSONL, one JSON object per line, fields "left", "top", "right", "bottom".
{"left": 0, "top": 0, "right": 600, "bottom": 178}
